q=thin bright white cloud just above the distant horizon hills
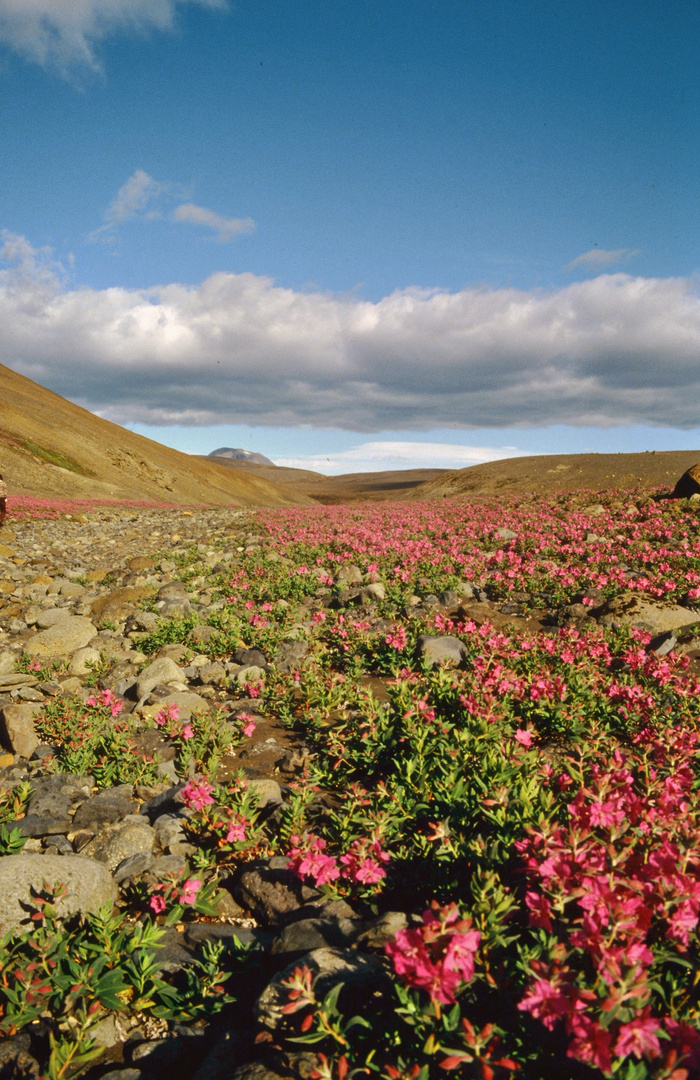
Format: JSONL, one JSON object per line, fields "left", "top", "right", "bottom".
{"left": 274, "top": 441, "right": 522, "bottom": 476}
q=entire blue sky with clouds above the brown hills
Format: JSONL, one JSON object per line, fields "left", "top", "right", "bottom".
{"left": 0, "top": 0, "right": 700, "bottom": 473}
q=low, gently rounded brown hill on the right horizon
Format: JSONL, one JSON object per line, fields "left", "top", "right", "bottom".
{"left": 404, "top": 450, "right": 700, "bottom": 499}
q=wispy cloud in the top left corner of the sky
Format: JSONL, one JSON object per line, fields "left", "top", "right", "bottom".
{"left": 0, "top": 0, "right": 226, "bottom": 78}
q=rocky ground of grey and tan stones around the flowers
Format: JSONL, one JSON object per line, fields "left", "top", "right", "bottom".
{"left": 0, "top": 509, "right": 697, "bottom": 1080}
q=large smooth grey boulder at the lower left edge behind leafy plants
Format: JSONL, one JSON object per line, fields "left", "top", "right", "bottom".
{"left": 0, "top": 852, "right": 118, "bottom": 933}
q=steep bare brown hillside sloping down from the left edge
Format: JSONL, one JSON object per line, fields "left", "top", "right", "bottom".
{"left": 0, "top": 364, "right": 312, "bottom": 507}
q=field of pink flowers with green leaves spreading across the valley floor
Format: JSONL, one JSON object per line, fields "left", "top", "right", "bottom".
{"left": 1, "top": 494, "right": 700, "bottom": 1080}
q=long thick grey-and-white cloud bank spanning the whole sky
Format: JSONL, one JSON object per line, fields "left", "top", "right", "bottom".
{"left": 0, "top": 234, "right": 700, "bottom": 433}
